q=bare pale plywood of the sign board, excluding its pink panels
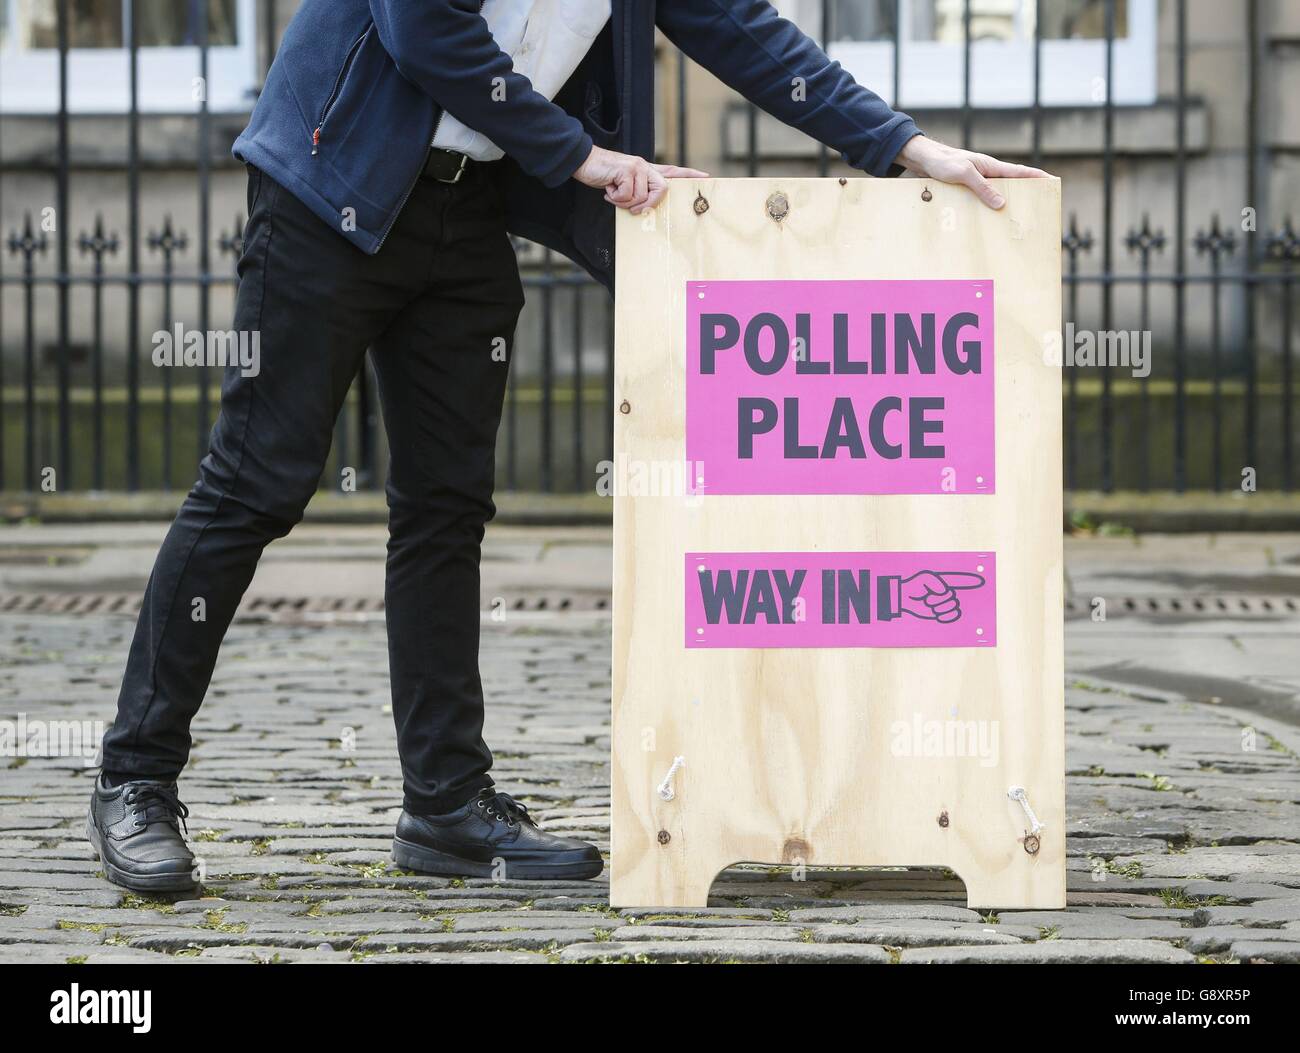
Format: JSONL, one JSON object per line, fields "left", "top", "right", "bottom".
{"left": 611, "top": 179, "right": 1065, "bottom": 907}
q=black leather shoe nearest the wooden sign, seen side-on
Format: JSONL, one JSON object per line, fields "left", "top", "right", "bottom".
{"left": 393, "top": 788, "right": 605, "bottom": 880}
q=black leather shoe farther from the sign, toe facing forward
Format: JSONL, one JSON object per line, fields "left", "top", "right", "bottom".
{"left": 86, "top": 777, "right": 195, "bottom": 892}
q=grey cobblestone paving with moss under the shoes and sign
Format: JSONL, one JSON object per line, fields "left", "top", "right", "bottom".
{"left": 0, "top": 533, "right": 1300, "bottom": 965}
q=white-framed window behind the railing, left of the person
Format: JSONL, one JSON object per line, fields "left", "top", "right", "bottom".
{"left": 0, "top": 0, "right": 257, "bottom": 113}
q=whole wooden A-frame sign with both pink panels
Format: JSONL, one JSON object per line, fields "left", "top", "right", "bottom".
{"left": 611, "top": 178, "right": 1065, "bottom": 907}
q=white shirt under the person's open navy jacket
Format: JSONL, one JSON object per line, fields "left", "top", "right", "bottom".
{"left": 433, "top": 0, "right": 610, "bottom": 161}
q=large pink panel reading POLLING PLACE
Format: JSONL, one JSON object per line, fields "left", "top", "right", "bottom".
{"left": 686, "top": 281, "right": 995, "bottom": 494}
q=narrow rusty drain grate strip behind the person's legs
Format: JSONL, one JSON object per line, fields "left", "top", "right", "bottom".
{"left": 0, "top": 590, "right": 610, "bottom": 621}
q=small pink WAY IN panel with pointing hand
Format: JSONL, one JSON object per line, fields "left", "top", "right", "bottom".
{"left": 686, "top": 553, "right": 997, "bottom": 647}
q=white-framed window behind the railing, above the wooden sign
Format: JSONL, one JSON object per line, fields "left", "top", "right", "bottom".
{"left": 776, "top": 0, "right": 1156, "bottom": 108}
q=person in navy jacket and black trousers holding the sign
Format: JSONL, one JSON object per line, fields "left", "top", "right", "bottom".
{"left": 88, "top": 0, "right": 1043, "bottom": 892}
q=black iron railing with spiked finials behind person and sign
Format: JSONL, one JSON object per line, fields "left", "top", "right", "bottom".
{"left": 0, "top": 0, "right": 1300, "bottom": 491}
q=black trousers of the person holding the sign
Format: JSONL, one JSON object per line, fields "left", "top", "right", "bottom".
{"left": 103, "top": 165, "right": 524, "bottom": 814}
